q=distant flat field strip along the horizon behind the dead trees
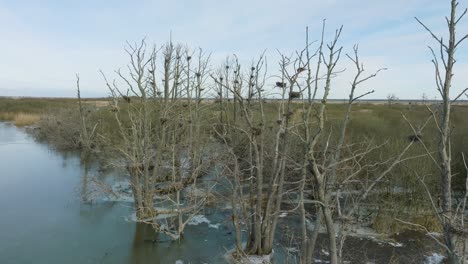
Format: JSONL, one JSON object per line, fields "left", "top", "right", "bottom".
{"left": 0, "top": 97, "right": 468, "bottom": 130}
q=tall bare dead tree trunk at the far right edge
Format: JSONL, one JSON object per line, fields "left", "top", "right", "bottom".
{"left": 416, "top": 0, "right": 468, "bottom": 263}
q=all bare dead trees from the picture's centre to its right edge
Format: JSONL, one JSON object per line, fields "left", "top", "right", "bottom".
{"left": 212, "top": 1, "right": 468, "bottom": 263}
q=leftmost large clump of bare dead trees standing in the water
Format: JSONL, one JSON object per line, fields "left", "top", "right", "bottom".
{"left": 95, "top": 40, "right": 218, "bottom": 239}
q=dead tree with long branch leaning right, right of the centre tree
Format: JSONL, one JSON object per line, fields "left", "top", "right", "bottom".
{"left": 288, "top": 23, "right": 413, "bottom": 263}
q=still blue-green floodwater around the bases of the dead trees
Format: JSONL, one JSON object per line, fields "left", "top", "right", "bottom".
{"left": 0, "top": 123, "right": 446, "bottom": 264}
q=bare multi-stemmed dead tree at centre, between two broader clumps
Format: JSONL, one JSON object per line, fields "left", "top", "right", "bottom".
{"left": 213, "top": 52, "right": 292, "bottom": 257}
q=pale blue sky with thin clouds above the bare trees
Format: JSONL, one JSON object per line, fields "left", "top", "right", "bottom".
{"left": 0, "top": 0, "right": 468, "bottom": 99}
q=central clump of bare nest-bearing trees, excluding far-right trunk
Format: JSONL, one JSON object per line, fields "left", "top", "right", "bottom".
{"left": 212, "top": 22, "right": 413, "bottom": 263}
